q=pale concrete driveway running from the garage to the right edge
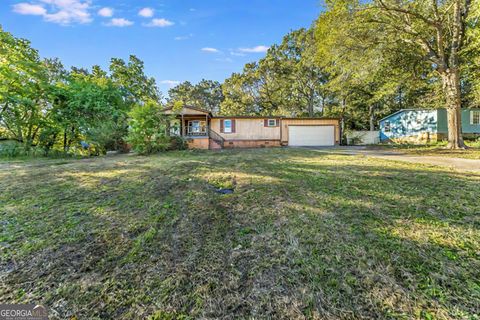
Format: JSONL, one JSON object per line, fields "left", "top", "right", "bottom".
{"left": 308, "top": 147, "right": 480, "bottom": 172}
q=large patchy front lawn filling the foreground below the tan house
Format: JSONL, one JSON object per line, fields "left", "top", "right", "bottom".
{"left": 0, "top": 149, "right": 480, "bottom": 319}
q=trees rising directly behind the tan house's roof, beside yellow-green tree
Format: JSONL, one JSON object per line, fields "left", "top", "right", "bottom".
{"left": 222, "top": 29, "right": 328, "bottom": 117}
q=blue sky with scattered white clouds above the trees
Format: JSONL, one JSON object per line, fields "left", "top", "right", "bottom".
{"left": 0, "top": 0, "right": 321, "bottom": 94}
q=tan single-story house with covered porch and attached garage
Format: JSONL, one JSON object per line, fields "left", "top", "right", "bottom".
{"left": 165, "top": 107, "right": 340, "bottom": 149}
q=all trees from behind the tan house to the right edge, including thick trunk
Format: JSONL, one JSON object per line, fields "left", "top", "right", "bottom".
{"left": 221, "top": 0, "right": 480, "bottom": 148}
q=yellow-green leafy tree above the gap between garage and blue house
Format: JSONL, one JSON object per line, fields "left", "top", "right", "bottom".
{"left": 315, "top": 1, "right": 446, "bottom": 130}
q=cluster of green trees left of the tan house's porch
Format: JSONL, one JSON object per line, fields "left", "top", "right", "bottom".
{"left": 0, "top": 28, "right": 163, "bottom": 153}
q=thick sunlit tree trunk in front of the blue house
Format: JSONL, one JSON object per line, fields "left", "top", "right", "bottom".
{"left": 442, "top": 69, "right": 465, "bottom": 149}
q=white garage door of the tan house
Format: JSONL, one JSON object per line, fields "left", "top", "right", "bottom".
{"left": 288, "top": 126, "right": 335, "bottom": 147}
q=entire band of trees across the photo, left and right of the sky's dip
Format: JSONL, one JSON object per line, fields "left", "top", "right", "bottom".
{"left": 0, "top": 0, "right": 480, "bottom": 152}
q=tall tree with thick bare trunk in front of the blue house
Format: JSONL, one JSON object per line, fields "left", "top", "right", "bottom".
{"left": 336, "top": 0, "right": 480, "bottom": 149}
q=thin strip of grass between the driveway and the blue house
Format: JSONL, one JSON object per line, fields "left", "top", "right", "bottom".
{"left": 371, "top": 141, "right": 480, "bottom": 160}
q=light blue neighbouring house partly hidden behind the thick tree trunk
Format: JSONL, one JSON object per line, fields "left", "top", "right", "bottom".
{"left": 380, "top": 109, "right": 480, "bottom": 142}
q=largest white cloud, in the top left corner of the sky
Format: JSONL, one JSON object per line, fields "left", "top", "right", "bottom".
{"left": 13, "top": 0, "right": 92, "bottom": 25}
